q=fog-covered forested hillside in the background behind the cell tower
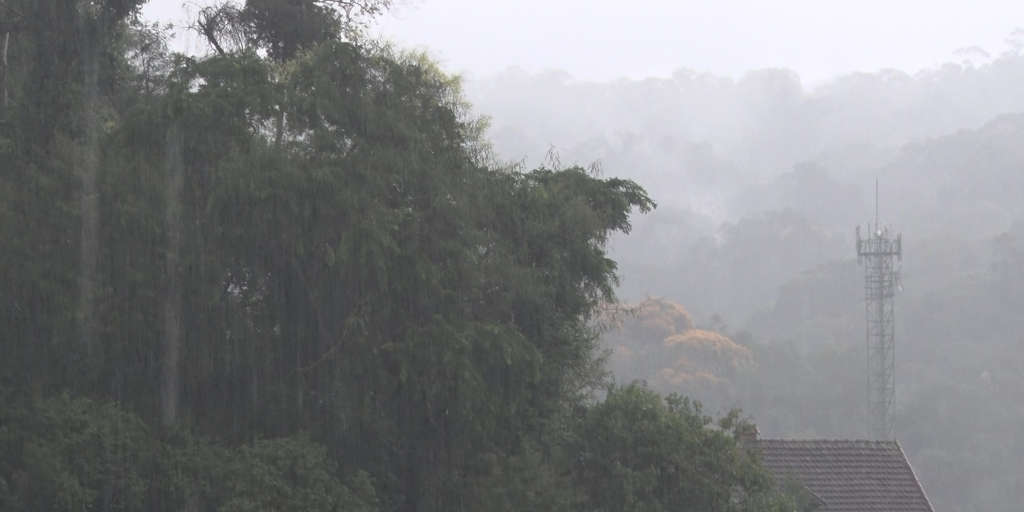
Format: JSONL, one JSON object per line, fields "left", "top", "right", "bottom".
{"left": 467, "top": 47, "right": 1024, "bottom": 512}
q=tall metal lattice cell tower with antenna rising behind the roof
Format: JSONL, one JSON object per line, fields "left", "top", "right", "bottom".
{"left": 857, "top": 180, "right": 903, "bottom": 440}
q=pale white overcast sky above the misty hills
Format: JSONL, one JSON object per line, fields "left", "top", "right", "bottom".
{"left": 144, "top": 0, "right": 1024, "bottom": 85}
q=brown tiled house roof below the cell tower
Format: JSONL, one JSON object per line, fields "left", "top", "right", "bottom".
{"left": 754, "top": 439, "right": 933, "bottom": 512}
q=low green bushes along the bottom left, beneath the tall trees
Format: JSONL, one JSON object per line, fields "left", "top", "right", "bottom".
{"left": 0, "top": 389, "right": 385, "bottom": 512}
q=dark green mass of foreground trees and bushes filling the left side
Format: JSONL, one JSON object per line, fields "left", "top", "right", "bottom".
{"left": 0, "top": 0, "right": 806, "bottom": 512}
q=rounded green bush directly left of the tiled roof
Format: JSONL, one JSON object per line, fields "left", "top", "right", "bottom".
{"left": 569, "top": 384, "right": 792, "bottom": 511}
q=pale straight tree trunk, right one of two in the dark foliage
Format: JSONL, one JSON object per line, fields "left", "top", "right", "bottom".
{"left": 160, "top": 122, "right": 184, "bottom": 427}
